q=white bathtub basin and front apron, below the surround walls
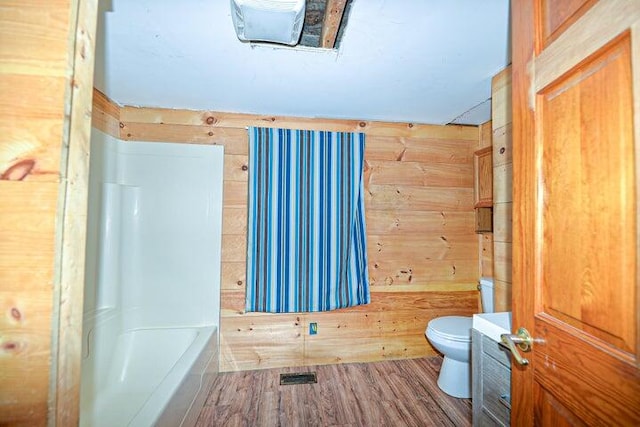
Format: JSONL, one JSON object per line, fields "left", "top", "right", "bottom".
{"left": 80, "top": 312, "right": 218, "bottom": 427}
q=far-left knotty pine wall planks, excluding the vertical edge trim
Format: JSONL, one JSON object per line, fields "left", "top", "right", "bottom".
{"left": 0, "top": 0, "right": 71, "bottom": 425}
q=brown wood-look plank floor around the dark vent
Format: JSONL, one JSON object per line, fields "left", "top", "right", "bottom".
{"left": 197, "top": 357, "right": 471, "bottom": 427}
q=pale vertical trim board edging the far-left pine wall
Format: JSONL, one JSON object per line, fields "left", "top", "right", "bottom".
{"left": 53, "top": 0, "right": 98, "bottom": 426}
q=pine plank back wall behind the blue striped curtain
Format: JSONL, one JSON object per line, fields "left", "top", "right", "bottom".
{"left": 94, "top": 93, "right": 479, "bottom": 371}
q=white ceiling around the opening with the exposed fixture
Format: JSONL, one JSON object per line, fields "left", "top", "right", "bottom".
{"left": 95, "top": 0, "right": 510, "bottom": 124}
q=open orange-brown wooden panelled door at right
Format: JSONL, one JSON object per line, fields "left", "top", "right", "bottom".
{"left": 512, "top": 0, "right": 640, "bottom": 426}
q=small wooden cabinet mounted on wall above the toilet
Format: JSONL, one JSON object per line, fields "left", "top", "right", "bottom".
{"left": 473, "top": 147, "right": 493, "bottom": 233}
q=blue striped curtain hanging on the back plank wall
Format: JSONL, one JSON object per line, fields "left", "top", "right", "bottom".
{"left": 246, "top": 128, "right": 370, "bottom": 313}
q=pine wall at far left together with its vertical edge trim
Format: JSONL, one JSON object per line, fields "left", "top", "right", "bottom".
{"left": 0, "top": 0, "right": 97, "bottom": 426}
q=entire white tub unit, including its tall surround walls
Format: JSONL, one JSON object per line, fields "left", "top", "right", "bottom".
{"left": 80, "top": 129, "right": 223, "bottom": 426}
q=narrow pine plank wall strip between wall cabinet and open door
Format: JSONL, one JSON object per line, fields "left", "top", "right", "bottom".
{"left": 491, "top": 67, "right": 513, "bottom": 311}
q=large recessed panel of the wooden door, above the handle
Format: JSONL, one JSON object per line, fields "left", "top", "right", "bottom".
{"left": 538, "top": 33, "right": 636, "bottom": 354}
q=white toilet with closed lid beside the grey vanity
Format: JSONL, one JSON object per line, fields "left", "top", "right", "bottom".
{"left": 425, "top": 277, "right": 493, "bottom": 398}
